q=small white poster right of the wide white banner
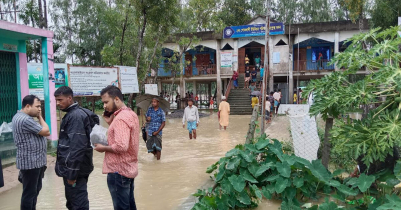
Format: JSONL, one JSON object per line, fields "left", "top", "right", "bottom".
{"left": 117, "top": 66, "right": 139, "bottom": 94}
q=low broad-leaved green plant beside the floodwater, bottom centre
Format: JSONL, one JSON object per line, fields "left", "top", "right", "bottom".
{"left": 193, "top": 136, "right": 394, "bottom": 210}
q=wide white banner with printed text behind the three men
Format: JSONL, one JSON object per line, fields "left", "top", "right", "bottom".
{"left": 68, "top": 65, "right": 119, "bottom": 96}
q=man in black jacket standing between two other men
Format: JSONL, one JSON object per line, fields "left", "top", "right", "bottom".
{"left": 54, "top": 86, "right": 99, "bottom": 210}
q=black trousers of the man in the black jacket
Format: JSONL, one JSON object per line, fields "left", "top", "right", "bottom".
{"left": 63, "top": 176, "right": 89, "bottom": 210}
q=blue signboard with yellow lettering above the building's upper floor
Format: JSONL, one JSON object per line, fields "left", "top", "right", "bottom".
{"left": 223, "top": 23, "right": 284, "bottom": 39}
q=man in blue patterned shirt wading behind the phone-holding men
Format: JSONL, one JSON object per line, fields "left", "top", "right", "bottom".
{"left": 146, "top": 98, "right": 166, "bottom": 160}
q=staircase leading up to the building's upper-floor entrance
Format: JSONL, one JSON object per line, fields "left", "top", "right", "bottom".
{"left": 227, "top": 74, "right": 252, "bottom": 115}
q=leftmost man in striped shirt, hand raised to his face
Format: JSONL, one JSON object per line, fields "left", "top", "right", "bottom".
{"left": 12, "top": 95, "right": 50, "bottom": 210}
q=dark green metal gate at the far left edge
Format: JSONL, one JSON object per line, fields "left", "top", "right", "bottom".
{"left": 0, "top": 51, "right": 18, "bottom": 124}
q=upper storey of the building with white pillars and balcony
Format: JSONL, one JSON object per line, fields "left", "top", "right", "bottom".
{"left": 158, "top": 16, "right": 369, "bottom": 106}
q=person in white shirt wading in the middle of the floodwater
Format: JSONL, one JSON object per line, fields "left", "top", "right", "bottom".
{"left": 182, "top": 99, "right": 199, "bottom": 139}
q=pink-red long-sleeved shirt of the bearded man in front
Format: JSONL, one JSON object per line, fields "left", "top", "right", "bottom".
{"left": 103, "top": 107, "right": 139, "bottom": 179}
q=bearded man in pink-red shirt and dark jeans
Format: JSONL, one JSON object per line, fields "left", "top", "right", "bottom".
{"left": 95, "top": 86, "right": 140, "bottom": 210}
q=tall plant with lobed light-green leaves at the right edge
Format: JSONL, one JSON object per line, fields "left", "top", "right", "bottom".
{"left": 305, "top": 27, "right": 401, "bottom": 167}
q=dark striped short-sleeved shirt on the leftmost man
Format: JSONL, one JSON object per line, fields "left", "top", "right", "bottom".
{"left": 12, "top": 111, "right": 47, "bottom": 170}
